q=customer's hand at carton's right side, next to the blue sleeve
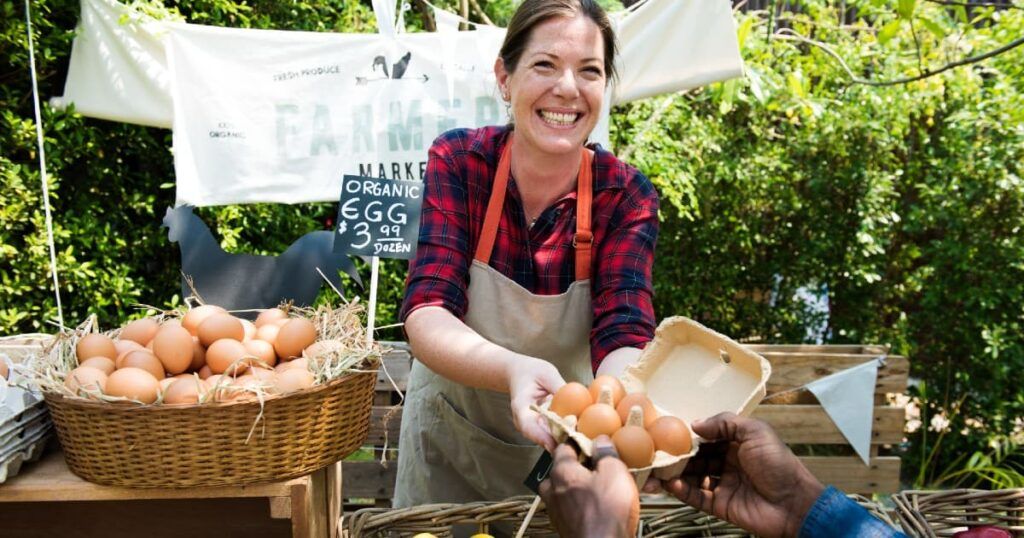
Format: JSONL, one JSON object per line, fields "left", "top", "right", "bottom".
{"left": 664, "top": 413, "right": 824, "bottom": 537}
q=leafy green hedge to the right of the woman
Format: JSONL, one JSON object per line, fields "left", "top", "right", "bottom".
{"left": 613, "top": 1, "right": 1024, "bottom": 487}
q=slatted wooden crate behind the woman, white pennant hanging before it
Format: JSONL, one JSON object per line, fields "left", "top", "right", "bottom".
{"left": 342, "top": 342, "right": 909, "bottom": 504}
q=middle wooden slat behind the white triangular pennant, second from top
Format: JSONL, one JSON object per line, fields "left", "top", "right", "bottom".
{"left": 754, "top": 405, "right": 904, "bottom": 445}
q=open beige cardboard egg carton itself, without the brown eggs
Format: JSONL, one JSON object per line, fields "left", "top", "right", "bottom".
{"left": 535, "top": 317, "right": 771, "bottom": 486}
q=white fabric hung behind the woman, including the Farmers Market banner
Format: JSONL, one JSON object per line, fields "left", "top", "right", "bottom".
{"left": 63, "top": 0, "right": 742, "bottom": 206}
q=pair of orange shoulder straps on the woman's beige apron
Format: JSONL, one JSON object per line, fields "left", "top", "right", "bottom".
{"left": 473, "top": 136, "right": 594, "bottom": 281}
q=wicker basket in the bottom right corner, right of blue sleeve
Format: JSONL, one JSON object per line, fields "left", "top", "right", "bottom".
{"left": 893, "top": 489, "right": 1024, "bottom": 538}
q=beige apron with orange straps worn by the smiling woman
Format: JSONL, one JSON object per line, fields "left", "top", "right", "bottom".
{"left": 394, "top": 136, "right": 593, "bottom": 507}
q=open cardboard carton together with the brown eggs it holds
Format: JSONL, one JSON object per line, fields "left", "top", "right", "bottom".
{"left": 535, "top": 317, "right": 771, "bottom": 485}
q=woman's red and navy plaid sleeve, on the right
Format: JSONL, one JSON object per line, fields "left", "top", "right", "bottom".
{"left": 590, "top": 169, "right": 658, "bottom": 372}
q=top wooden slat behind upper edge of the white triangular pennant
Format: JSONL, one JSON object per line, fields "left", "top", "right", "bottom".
{"left": 761, "top": 354, "right": 910, "bottom": 395}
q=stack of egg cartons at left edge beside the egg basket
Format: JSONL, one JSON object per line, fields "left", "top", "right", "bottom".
{"left": 0, "top": 335, "right": 53, "bottom": 484}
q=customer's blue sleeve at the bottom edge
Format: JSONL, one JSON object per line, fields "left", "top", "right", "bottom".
{"left": 800, "top": 486, "right": 906, "bottom": 538}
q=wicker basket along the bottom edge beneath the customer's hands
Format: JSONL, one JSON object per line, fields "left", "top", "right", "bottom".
{"left": 348, "top": 495, "right": 896, "bottom": 538}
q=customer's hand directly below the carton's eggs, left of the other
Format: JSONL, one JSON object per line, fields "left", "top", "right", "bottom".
{"left": 541, "top": 436, "right": 640, "bottom": 538}
